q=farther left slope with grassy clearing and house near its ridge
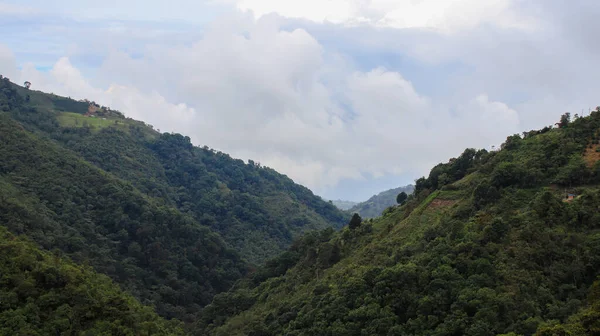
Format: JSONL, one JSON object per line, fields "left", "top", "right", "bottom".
{"left": 0, "top": 77, "right": 346, "bottom": 264}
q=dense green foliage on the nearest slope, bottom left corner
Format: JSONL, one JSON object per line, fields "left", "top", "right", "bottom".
{"left": 0, "top": 227, "right": 184, "bottom": 336}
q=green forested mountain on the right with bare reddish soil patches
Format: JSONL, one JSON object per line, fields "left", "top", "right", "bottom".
{"left": 199, "top": 108, "right": 600, "bottom": 336}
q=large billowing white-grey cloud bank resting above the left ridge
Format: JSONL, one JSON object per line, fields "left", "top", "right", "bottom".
{"left": 2, "top": 16, "right": 518, "bottom": 194}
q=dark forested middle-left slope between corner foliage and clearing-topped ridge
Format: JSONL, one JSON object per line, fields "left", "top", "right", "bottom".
{"left": 0, "top": 115, "right": 246, "bottom": 319}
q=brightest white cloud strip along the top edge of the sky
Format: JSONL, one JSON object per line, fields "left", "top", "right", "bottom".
{"left": 230, "top": 0, "right": 534, "bottom": 32}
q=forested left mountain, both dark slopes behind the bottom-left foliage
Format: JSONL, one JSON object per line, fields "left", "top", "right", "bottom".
{"left": 0, "top": 79, "right": 347, "bottom": 328}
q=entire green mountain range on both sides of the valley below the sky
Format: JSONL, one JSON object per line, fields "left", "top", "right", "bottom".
{"left": 0, "top": 79, "right": 600, "bottom": 336}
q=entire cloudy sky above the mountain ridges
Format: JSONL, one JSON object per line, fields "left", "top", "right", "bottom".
{"left": 0, "top": 0, "right": 600, "bottom": 201}
